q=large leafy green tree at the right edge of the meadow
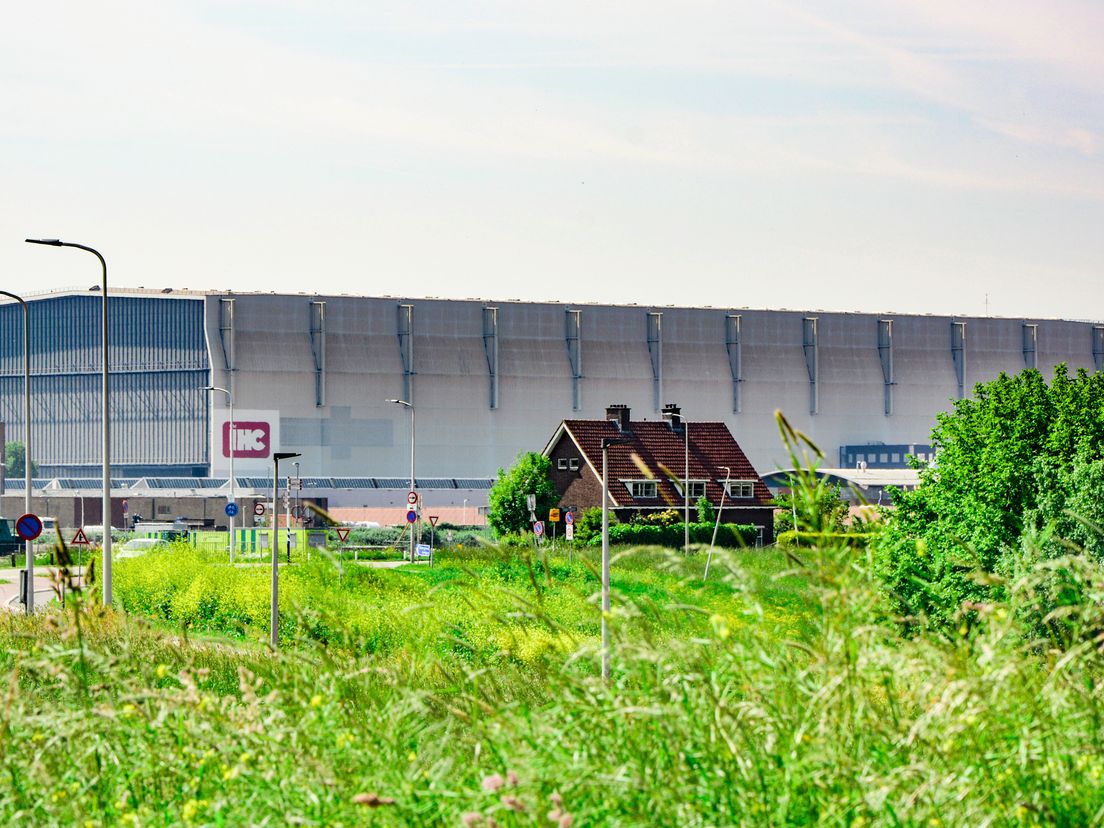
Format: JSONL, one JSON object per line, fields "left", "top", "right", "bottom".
{"left": 875, "top": 365, "right": 1104, "bottom": 622}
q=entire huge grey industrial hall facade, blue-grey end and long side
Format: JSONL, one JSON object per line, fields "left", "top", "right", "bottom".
{"left": 0, "top": 290, "right": 1104, "bottom": 478}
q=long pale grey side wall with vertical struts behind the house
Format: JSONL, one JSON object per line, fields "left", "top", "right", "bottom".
{"left": 206, "top": 295, "right": 1098, "bottom": 477}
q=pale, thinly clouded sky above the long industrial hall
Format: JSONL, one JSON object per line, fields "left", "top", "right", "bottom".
{"left": 0, "top": 0, "right": 1104, "bottom": 320}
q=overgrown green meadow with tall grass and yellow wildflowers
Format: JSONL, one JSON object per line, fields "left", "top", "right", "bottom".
{"left": 0, "top": 541, "right": 1104, "bottom": 826}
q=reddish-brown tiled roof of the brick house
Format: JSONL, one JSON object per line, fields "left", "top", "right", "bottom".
{"left": 563, "top": 420, "right": 773, "bottom": 508}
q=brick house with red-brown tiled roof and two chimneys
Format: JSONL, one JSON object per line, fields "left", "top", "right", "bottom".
{"left": 542, "top": 405, "right": 774, "bottom": 543}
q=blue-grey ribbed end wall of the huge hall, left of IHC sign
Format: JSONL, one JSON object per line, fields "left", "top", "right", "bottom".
{"left": 0, "top": 293, "right": 209, "bottom": 474}
